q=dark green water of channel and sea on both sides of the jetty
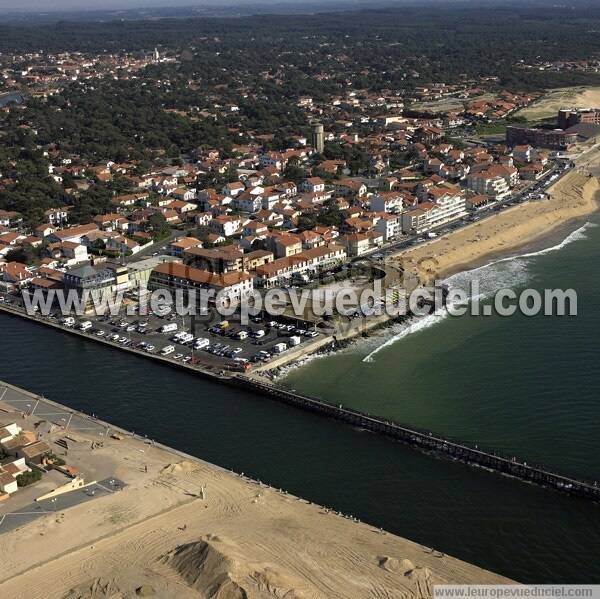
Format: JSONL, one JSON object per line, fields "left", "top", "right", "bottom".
{"left": 0, "top": 218, "right": 600, "bottom": 583}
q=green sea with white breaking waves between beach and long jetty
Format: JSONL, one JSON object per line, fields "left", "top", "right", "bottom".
{"left": 281, "top": 217, "right": 600, "bottom": 480}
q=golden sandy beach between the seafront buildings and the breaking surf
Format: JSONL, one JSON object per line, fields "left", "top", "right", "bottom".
{"left": 394, "top": 166, "right": 600, "bottom": 284}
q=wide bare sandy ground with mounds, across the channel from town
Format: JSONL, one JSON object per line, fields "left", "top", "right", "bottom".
{"left": 0, "top": 384, "right": 508, "bottom": 599}
